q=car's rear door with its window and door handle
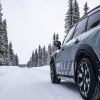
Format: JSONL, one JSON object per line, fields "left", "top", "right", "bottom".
{"left": 60, "top": 17, "right": 87, "bottom": 76}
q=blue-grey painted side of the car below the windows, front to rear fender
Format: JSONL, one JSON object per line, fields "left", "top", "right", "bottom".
{"left": 52, "top": 26, "right": 100, "bottom": 81}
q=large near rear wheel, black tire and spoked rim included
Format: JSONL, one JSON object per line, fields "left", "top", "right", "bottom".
{"left": 77, "top": 58, "right": 96, "bottom": 100}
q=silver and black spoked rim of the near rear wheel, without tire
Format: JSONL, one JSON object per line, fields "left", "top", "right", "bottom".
{"left": 78, "top": 62, "right": 90, "bottom": 97}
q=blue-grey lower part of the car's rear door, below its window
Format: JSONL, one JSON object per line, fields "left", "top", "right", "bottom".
{"left": 62, "top": 39, "right": 77, "bottom": 76}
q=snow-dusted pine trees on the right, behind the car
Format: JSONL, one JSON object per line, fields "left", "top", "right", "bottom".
{"left": 26, "top": 0, "right": 89, "bottom": 67}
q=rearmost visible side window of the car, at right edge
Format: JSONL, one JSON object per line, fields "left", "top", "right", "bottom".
{"left": 87, "top": 11, "right": 100, "bottom": 30}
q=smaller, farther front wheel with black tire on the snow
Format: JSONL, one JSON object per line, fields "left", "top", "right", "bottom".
{"left": 50, "top": 62, "right": 61, "bottom": 84}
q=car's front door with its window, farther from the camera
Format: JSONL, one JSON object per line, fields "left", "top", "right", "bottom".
{"left": 58, "top": 25, "right": 76, "bottom": 75}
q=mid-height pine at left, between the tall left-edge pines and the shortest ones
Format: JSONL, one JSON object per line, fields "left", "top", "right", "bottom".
{"left": 8, "top": 43, "right": 15, "bottom": 66}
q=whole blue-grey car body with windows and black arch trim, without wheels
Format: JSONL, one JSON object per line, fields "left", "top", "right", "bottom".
{"left": 51, "top": 6, "right": 100, "bottom": 99}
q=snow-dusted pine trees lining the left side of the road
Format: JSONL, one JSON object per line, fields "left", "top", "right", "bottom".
{"left": 0, "top": 3, "right": 18, "bottom": 66}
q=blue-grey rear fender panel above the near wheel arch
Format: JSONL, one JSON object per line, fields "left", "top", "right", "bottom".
{"left": 80, "top": 26, "right": 100, "bottom": 59}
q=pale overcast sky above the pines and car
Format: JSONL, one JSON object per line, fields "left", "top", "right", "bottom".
{"left": 2, "top": 0, "right": 100, "bottom": 63}
